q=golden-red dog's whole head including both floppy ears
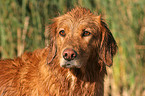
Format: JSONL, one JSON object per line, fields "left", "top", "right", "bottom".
{"left": 48, "top": 7, "right": 117, "bottom": 68}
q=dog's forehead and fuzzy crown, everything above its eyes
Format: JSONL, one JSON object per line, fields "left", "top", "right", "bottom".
{"left": 54, "top": 8, "right": 101, "bottom": 32}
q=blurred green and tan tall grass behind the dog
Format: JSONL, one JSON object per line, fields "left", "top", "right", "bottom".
{"left": 0, "top": 0, "right": 145, "bottom": 96}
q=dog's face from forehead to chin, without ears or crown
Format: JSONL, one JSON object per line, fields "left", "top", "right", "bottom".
{"left": 57, "top": 17, "right": 96, "bottom": 68}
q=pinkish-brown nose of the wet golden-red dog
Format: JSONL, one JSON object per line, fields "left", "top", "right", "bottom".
{"left": 62, "top": 48, "right": 77, "bottom": 61}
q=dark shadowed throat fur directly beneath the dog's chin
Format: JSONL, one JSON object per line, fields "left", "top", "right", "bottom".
{"left": 69, "top": 59, "right": 106, "bottom": 83}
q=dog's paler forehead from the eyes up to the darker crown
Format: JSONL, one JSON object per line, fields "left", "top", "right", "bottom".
{"left": 57, "top": 15, "right": 100, "bottom": 33}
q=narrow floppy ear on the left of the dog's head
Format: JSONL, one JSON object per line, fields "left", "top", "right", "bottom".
{"left": 47, "top": 23, "right": 57, "bottom": 64}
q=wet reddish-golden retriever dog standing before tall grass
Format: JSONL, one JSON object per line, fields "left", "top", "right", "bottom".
{"left": 0, "top": 7, "right": 117, "bottom": 96}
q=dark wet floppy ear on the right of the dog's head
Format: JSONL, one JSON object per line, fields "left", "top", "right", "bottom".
{"left": 99, "top": 20, "right": 117, "bottom": 67}
